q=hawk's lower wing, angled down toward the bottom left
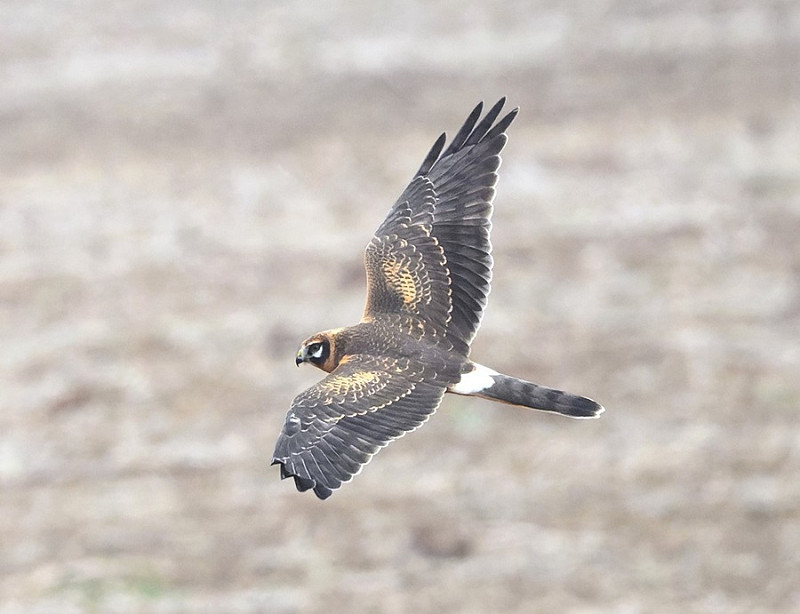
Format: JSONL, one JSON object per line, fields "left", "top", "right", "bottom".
{"left": 272, "top": 355, "right": 446, "bottom": 499}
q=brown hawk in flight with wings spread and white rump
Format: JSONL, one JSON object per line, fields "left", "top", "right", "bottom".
{"left": 272, "top": 98, "right": 603, "bottom": 499}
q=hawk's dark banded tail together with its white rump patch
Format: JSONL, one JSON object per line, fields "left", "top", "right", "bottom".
{"left": 450, "top": 364, "right": 605, "bottom": 418}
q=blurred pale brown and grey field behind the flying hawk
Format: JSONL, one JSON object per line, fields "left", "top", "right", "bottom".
{"left": 0, "top": 0, "right": 800, "bottom": 614}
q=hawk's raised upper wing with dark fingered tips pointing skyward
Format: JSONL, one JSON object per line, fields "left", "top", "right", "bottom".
{"left": 364, "top": 98, "right": 517, "bottom": 354}
